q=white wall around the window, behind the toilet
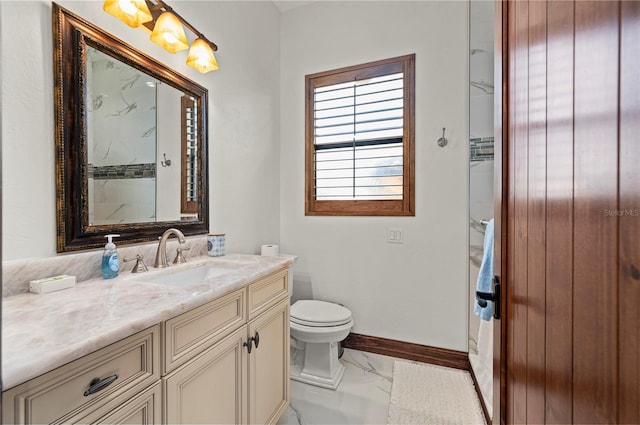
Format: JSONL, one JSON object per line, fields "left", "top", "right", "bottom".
{"left": 280, "top": 1, "right": 469, "bottom": 351}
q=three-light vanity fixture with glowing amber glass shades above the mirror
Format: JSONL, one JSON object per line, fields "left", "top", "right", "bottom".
{"left": 103, "top": 0, "right": 219, "bottom": 74}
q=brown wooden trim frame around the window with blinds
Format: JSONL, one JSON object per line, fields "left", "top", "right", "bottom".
{"left": 305, "top": 54, "right": 415, "bottom": 216}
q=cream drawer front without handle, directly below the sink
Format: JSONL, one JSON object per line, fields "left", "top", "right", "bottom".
{"left": 163, "top": 289, "right": 247, "bottom": 375}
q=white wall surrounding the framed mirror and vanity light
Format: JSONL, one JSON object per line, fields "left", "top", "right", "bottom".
{"left": 0, "top": 0, "right": 280, "bottom": 260}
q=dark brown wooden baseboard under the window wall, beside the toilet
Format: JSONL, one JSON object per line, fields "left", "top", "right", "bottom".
{"left": 342, "top": 333, "right": 471, "bottom": 370}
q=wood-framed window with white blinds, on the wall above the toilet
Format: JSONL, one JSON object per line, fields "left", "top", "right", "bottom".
{"left": 305, "top": 55, "right": 415, "bottom": 216}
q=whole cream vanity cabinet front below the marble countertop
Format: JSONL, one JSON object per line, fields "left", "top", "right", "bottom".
{"left": 2, "top": 268, "right": 289, "bottom": 424}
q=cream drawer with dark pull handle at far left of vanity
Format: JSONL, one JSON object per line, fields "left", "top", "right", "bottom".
{"left": 2, "top": 326, "right": 160, "bottom": 424}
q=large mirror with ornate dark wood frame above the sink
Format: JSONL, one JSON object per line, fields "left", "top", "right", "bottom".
{"left": 52, "top": 3, "right": 209, "bottom": 252}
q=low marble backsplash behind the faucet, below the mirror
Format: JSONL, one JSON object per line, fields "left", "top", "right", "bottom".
{"left": 2, "top": 235, "right": 207, "bottom": 298}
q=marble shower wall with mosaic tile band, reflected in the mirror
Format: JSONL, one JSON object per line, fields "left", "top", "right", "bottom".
{"left": 86, "top": 47, "right": 157, "bottom": 226}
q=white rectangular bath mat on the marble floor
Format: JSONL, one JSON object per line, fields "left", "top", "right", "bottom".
{"left": 387, "top": 361, "right": 485, "bottom": 425}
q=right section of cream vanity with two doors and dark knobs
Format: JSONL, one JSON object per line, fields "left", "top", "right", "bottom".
{"left": 162, "top": 270, "right": 289, "bottom": 424}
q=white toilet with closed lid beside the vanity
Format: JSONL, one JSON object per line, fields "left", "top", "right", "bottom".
{"left": 290, "top": 300, "right": 353, "bottom": 390}
